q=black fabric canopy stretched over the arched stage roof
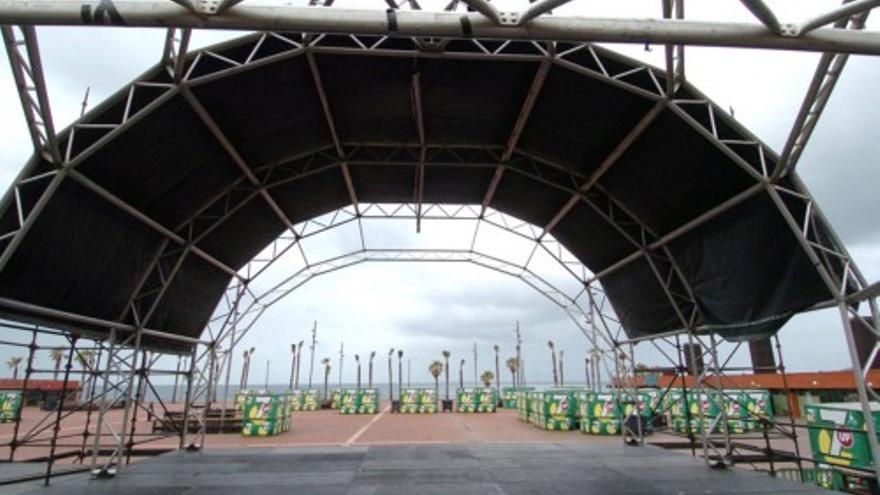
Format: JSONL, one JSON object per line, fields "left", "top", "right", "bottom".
{"left": 0, "top": 35, "right": 830, "bottom": 348}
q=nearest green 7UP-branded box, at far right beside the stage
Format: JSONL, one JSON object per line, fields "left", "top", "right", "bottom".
{"left": 806, "top": 402, "right": 880, "bottom": 469}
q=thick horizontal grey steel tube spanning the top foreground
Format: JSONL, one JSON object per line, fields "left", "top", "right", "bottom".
{"left": 0, "top": 0, "right": 880, "bottom": 55}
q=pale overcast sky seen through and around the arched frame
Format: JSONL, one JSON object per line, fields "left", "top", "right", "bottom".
{"left": 0, "top": 0, "right": 880, "bottom": 390}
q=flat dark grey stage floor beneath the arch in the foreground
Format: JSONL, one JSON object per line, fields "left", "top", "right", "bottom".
{"left": 6, "top": 442, "right": 830, "bottom": 495}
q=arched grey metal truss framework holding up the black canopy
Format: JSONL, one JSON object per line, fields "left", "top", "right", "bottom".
{"left": 0, "top": 0, "right": 880, "bottom": 483}
